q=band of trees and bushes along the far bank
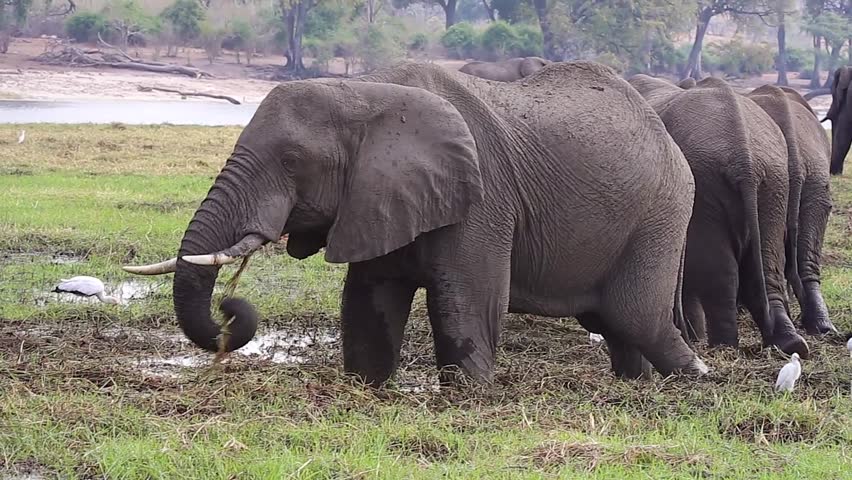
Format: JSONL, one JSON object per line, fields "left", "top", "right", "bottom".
{"left": 0, "top": 0, "right": 852, "bottom": 79}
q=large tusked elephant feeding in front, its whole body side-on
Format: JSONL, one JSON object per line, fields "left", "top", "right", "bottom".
{"left": 125, "top": 63, "right": 707, "bottom": 384}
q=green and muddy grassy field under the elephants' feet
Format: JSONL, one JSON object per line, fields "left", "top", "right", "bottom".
{"left": 0, "top": 125, "right": 852, "bottom": 479}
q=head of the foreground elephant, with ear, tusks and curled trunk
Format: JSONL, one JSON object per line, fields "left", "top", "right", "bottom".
{"left": 125, "top": 81, "right": 483, "bottom": 351}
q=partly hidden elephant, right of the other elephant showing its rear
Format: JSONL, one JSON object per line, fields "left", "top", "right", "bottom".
{"left": 746, "top": 85, "right": 837, "bottom": 335}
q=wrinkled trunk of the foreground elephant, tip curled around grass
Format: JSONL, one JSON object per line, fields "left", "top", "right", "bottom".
{"left": 172, "top": 152, "right": 292, "bottom": 352}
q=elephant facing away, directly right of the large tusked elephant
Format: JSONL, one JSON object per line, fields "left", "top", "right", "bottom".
{"left": 630, "top": 75, "right": 808, "bottom": 358}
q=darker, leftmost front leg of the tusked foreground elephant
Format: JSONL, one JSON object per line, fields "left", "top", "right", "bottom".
{"left": 340, "top": 264, "right": 417, "bottom": 386}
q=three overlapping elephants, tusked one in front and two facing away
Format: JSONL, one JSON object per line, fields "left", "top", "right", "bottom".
{"left": 124, "top": 61, "right": 835, "bottom": 385}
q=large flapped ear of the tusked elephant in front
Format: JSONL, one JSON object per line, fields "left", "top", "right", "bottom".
{"left": 325, "top": 81, "right": 483, "bottom": 263}
